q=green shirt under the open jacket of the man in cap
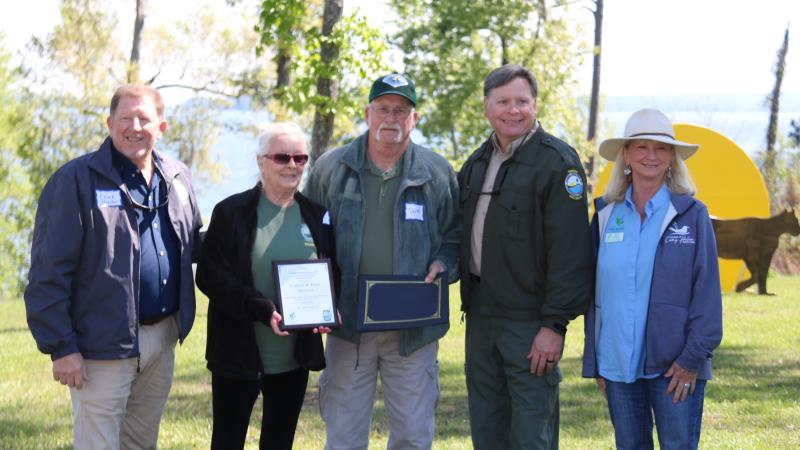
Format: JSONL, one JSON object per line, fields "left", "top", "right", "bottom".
{"left": 358, "top": 153, "right": 405, "bottom": 275}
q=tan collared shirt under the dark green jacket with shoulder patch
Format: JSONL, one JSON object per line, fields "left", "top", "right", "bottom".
{"left": 469, "top": 122, "right": 539, "bottom": 276}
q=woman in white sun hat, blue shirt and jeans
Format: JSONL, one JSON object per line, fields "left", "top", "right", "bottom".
{"left": 583, "top": 109, "right": 722, "bottom": 449}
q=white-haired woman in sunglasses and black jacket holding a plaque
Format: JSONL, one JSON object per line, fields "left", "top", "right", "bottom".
{"left": 196, "top": 123, "right": 338, "bottom": 449}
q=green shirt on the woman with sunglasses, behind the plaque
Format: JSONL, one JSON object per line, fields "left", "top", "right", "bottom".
{"left": 250, "top": 195, "right": 317, "bottom": 373}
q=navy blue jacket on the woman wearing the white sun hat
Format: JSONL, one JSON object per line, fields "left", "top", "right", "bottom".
{"left": 583, "top": 194, "right": 722, "bottom": 380}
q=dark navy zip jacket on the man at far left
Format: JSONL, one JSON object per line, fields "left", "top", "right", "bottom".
{"left": 25, "top": 138, "right": 202, "bottom": 360}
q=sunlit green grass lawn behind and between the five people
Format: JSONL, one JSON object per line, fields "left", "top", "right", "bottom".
{"left": 0, "top": 277, "right": 800, "bottom": 449}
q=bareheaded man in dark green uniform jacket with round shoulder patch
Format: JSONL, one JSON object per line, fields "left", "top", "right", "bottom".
{"left": 458, "top": 65, "right": 593, "bottom": 450}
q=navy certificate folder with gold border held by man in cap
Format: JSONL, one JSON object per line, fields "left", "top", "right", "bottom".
{"left": 356, "top": 273, "right": 450, "bottom": 331}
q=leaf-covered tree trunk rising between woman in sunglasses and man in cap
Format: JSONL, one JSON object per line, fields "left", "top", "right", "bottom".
{"left": 311, "top": 0, "right": 344, "bottom": 159}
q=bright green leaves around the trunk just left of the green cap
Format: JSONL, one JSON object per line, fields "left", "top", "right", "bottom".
{"left": 256, "top": 0, "right": 387, "bottom": 151}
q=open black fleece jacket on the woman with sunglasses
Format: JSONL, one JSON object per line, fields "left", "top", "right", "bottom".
{"left": 200, "top": 183, "right": 339, "bottom": 379}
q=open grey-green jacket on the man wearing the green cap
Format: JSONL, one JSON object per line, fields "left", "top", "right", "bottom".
{"left": 303, "top": 133, "right": 461, "bottom": 356}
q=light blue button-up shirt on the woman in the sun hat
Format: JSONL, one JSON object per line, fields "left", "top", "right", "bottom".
{"left": 597, "top": 185, "right": 670, "bottom": 383}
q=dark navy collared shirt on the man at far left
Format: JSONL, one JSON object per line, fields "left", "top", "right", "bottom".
{"left": 111, "top": 147, "right": 181, "bottom": 321}
